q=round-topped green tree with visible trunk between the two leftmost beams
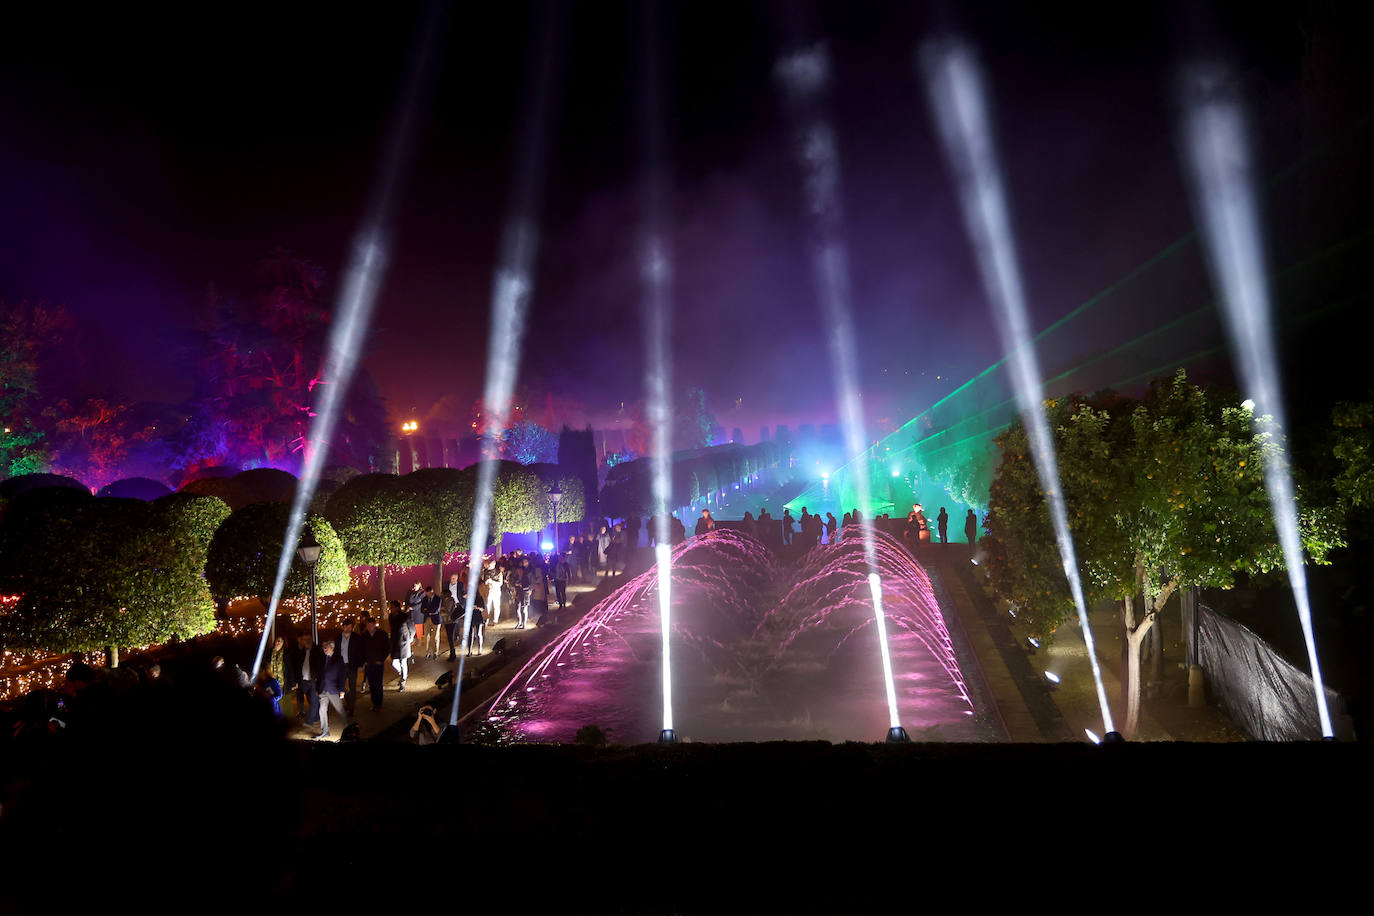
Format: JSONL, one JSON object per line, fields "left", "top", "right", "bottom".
{"left": 326, "top": 474, "right": 430, "bottom": 612}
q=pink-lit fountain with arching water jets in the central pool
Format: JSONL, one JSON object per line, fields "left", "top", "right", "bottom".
{"left": 469, "top": 530, "right": 985, "bottom": 743}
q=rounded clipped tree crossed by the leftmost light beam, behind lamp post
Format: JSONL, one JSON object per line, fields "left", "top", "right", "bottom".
{"left": 205, "top": 503, "right": 349, "bottom": 606}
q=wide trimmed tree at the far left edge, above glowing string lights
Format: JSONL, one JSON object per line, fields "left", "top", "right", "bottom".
{"left": 0, "top": 489, "right": 228, "bottom": 665}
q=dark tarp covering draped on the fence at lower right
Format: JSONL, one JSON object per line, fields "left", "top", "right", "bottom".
{"left": 1197, "top": 604, "right": 1355, "bottom": 742}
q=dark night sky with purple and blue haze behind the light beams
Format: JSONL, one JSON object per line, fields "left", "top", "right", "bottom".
{"left": 0, "top": 3, "right": 1374, "bottom": 441}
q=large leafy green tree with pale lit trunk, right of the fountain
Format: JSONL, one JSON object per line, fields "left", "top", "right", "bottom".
{"left": 987, "top": 371, "right": 1340, "bottom": 736}
